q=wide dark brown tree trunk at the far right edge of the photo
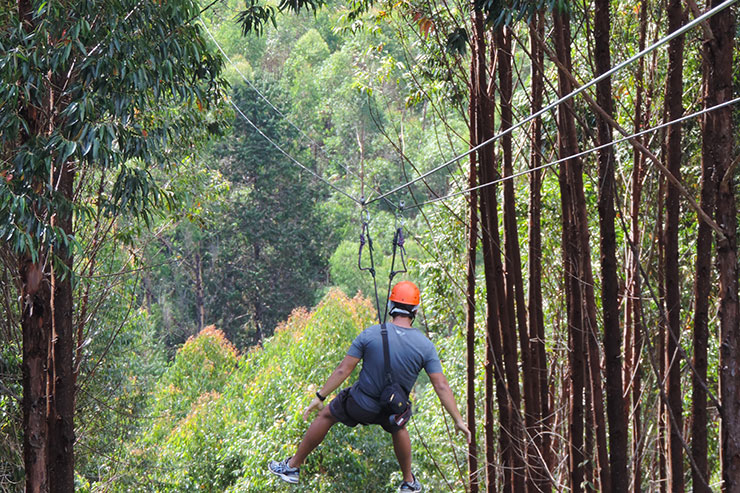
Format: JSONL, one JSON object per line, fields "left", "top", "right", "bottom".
{"left": 702, "top": 0, "right": 740, "bottom": 493}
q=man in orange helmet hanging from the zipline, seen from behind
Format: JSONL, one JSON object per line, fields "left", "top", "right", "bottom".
{"left": 268, "top": 281, "right": 471, "bottom": 493}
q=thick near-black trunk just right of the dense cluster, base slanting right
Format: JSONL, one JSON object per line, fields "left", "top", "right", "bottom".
{"left": 594, "top": 0, "right": 629, "bottom": 493}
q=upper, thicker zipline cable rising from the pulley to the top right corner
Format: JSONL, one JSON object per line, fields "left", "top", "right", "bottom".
{"left": 370, "top": 0, "right": 737, "bottom": 202}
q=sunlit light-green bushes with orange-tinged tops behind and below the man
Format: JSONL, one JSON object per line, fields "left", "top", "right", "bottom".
{"left": 98, "top": 291, "right": 472, "bottom": 493}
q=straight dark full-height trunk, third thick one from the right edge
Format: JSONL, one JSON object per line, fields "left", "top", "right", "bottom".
{"left": 665, "top": 0, "right": 684, "bottom": 492}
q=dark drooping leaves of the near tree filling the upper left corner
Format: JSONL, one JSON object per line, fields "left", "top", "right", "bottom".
{"left": 0, "top": 0, "right": 228, "bottom": 258}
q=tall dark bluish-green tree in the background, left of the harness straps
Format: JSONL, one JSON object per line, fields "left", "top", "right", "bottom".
{"left": 206, "top": 79, "right": 334, "bottom": 337}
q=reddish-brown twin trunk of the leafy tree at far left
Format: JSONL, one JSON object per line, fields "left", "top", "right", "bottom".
{"left": 17, "top": 0, "right": 75, "bottom": 486}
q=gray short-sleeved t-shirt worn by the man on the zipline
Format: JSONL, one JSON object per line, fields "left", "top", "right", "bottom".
{"left": 347, "top": 322, "right": 442, "bottom": 412}
